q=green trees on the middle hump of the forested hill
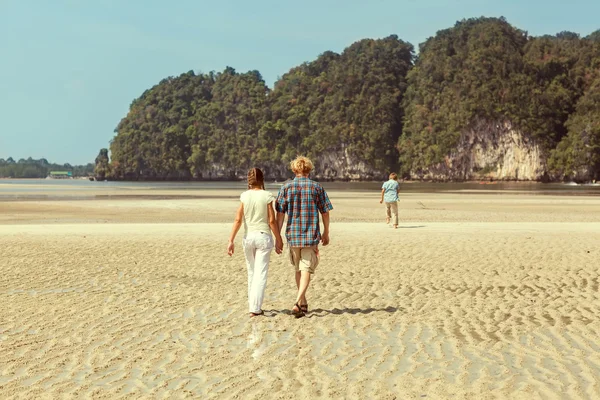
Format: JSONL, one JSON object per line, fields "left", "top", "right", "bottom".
{"left": 269, "top": 36, "right": 413, "bottom": 171}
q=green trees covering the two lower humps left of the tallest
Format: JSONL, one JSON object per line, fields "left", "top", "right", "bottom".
{"left": 111, "top": 36, "right": 413, "bottom": 179}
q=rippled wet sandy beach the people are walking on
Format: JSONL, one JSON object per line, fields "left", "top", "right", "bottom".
{"left": 0, "top": 187, "right": 600, "bottom": 399}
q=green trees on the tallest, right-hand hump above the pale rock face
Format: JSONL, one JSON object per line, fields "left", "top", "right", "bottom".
{"left": 399, "top": 18, "right": 600, "bottom": 177}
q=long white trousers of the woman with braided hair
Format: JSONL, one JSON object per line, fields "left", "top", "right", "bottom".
{"left": 242, "top": 232, "right": 274, "bottom": 314}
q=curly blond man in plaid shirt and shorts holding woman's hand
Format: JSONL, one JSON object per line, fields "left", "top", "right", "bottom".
{"left": 275, "top": 157, "right": 333, "bottom": 318}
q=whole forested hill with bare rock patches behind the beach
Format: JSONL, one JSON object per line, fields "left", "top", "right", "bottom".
{"left": 104, "top": 18, "right": 600, "bottom": 180}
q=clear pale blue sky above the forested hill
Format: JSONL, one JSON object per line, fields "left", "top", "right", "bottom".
{"left": 0, "top": 0, "right": 600, "bottom": 164}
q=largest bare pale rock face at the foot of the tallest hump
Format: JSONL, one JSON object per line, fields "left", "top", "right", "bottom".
{"left": 411, "top": 120, "right": 548, "bottom": 181}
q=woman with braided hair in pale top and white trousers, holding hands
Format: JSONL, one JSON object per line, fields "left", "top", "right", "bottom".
{"left": 227, "top": 168, "right": 283, "bottom": 317}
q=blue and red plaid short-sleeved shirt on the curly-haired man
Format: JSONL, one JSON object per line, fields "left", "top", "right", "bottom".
{"left": 275, "top": 177, "right": 333, "bottom": 247}
